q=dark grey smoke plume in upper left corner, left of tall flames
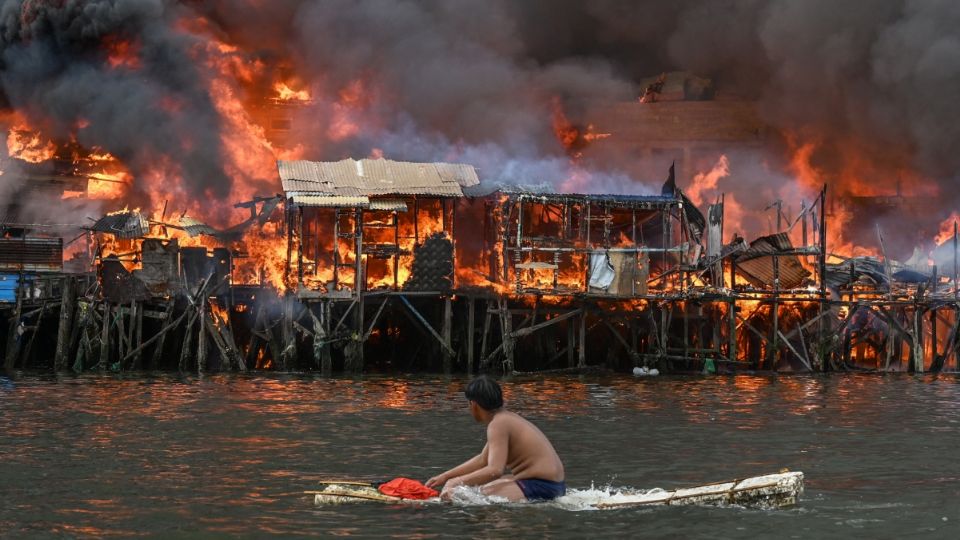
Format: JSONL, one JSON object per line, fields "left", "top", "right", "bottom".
{"left": 0, "top": 0, "right": 230, "bottom": 209}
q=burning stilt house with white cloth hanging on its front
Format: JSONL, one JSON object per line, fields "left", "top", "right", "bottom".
{"left": 457, "top": 186, "right": 696, "bottom": 298}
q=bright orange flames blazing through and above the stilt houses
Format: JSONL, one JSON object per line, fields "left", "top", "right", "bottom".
{"left": 3, "top": 4, "right": 956, "bottom": 304}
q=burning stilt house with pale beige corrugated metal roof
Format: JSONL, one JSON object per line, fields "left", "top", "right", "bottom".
{"left": 278, "top": 159, "right": 479, "bottom": 298}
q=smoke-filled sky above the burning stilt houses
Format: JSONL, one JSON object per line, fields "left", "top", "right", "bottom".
{"left": 0, "top": 0, "right": 960, "bottom": 205}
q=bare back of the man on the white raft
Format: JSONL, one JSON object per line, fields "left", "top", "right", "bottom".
{"left": 487, "top": 410, "right": 564, "bottom": 482}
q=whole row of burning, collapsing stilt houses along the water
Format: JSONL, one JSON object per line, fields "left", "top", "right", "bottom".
{"left": 0, "top": 155, "right": 960, "bottom": 373}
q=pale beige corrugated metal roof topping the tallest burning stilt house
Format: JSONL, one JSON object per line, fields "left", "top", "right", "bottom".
{"left": 277, "top": 159, "right": 480, "bottom": 197}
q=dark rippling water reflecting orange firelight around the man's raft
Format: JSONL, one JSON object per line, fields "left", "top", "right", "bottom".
{"left": 0, "top": 374, "right": 960, "bottom": 538}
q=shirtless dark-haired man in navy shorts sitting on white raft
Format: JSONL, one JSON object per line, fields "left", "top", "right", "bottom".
{"left": 426, "top": 375, "right": 567, "bottom": 501}
